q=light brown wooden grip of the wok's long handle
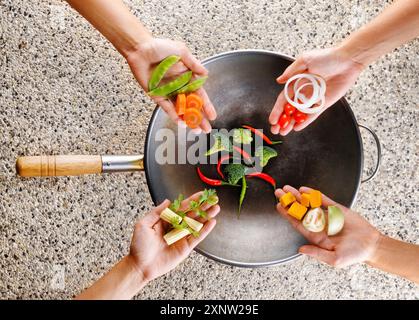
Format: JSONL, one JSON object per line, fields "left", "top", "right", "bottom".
{"left": 16, "top": 155, "right": 102, "bottom": 177}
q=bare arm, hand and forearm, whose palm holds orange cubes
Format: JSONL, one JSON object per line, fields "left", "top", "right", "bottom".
{"left": 275, "top": 186, "right": 419, "bottom": 284}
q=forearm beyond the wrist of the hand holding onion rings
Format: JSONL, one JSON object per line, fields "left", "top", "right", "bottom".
{"left": 340, "top": 0, "right": 419, "bottom": 66}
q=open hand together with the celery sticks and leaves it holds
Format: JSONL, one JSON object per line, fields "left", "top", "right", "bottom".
{"left": 129, "top": 190, "right": 220, "bottom": 281}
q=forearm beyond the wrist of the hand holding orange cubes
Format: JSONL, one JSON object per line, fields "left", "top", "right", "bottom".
{"left": 367, "top": 236, "right": 419, "bottom": 284}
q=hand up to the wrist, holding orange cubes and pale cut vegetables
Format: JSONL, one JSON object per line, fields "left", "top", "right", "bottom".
{"left": 275, "top": 186, "right": 381, "bottom": 267}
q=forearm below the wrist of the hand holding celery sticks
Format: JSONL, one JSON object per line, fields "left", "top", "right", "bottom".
{"left": 75, "top": 256, "right": 147, "bottom": 300}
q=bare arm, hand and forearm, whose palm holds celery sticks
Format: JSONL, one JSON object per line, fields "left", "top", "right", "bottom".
{"left": 76, "top": 192, "right": 220, "bottom": 300}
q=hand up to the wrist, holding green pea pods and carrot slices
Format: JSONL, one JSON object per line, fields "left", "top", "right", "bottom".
{"left": 126, "top": 38, "right": 217, "bottom": 133}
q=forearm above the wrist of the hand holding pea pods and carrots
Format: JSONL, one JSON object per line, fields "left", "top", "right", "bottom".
{"left": 67, "top": 0, "right": 151, "bottom": 57}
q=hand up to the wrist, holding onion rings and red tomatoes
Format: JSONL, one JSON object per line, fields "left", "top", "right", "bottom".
{"left": 269, "top": 47, "right": 364, "bottom": 136}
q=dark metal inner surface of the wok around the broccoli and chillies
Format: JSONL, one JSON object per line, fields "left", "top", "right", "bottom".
{"left": 146, "top": 51, "right": 362, "bottom": 266}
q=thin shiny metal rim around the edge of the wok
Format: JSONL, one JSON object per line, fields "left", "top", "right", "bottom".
{"left": 144, "top": 49, "right": 364, "bottom": 268}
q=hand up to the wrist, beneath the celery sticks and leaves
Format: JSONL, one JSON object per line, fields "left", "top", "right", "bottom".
{"left": 129, "top": 192, "right": 220, "bottom": 281}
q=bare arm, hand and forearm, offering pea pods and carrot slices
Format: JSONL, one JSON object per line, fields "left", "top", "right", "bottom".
{"left": 67, "top": 0, "right": 217, "bottom": 133}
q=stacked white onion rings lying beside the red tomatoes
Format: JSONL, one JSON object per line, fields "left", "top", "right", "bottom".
{"left": 284, "top": 73, "right": 326, "bottom": 114}
